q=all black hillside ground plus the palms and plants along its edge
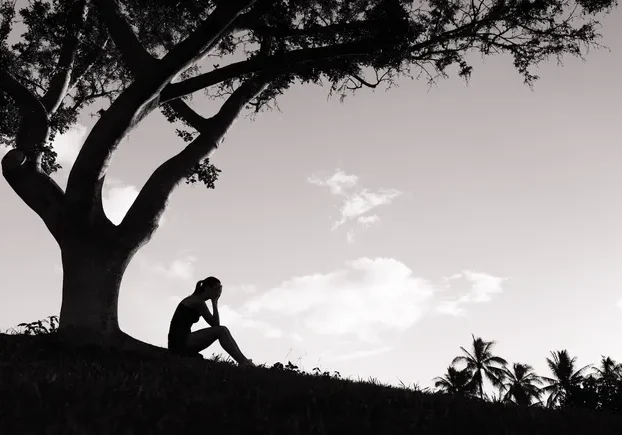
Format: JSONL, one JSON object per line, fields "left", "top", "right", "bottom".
{"left": 0, "top": 316, "right": 622, "bottom": 435}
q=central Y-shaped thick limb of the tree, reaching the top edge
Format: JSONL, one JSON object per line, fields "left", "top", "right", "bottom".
{"left": 66, "top": 0, "right": 255, "bottom": 215}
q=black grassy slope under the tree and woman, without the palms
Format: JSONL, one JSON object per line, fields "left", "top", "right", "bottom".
{"left": 0, "top": 334, "right": 622, "bottom": 435}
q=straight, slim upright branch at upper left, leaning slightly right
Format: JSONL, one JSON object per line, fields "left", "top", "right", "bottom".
{"left": 41, "top": 0, "right": 87, "bottom": 113}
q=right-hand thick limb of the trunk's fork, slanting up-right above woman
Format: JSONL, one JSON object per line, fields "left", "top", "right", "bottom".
{"left": 120, "top": 76, "right": 269, "bottom": 245}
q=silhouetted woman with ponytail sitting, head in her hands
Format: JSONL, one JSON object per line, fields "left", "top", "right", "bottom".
{"left": 168, "top": 276, "right": 254, "bottom": 365}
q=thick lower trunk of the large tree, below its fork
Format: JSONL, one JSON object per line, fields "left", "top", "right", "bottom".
{"left": 51, "top": 217, "right": 172, "bottom": 356}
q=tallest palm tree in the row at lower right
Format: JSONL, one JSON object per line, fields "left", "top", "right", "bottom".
{"left": 451, "top": 334, "right": 507, "bottom": 399}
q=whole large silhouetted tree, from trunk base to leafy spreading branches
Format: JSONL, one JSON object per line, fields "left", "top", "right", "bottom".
{"left": 0, "top": 0, "right": 615, "bottom": 352}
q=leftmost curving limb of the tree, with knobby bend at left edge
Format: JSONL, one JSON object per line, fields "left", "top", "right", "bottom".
{"left": 0, "top": 69, "right": 64, "bottom": 241}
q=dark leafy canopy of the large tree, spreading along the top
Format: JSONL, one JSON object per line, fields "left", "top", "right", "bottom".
{"left": 0, "top": 0, "right": 616, "bottom": 182}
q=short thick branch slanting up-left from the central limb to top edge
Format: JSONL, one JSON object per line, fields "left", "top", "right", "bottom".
{"left": 93, "top": 0, "right": 156, "bottom": 77}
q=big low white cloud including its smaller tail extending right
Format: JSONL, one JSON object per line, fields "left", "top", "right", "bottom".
{"left": 240, "top": 258, "right": 507, "bottom": 343}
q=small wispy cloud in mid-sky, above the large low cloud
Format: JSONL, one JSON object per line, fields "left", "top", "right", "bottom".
{"left": 308, "top": 169, "right": 403, "bottom": 243}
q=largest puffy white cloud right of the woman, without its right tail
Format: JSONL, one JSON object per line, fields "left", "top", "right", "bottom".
{"left": 243, "top": 258, "right": 435, "bottom": 342}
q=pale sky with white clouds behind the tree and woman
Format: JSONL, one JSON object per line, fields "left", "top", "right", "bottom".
{"left": 0, "top": 5, "right": 622, "bottom": 402}
